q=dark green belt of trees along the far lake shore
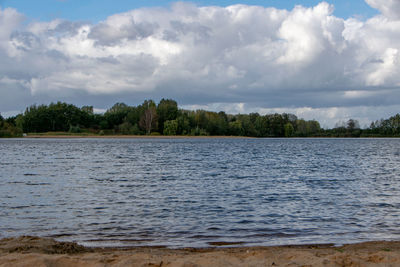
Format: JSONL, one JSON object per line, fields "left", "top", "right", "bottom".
{"left": 0, "top": 99, "right": 400, "bottom": 137}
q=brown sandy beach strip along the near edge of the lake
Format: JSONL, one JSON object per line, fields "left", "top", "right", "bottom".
{"left": 0, "top": 236, "right": 400, "bottom": 267}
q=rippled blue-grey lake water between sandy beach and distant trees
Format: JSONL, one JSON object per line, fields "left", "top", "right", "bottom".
{"left": 0, "top": 138, "right": 400, "bottom": 247}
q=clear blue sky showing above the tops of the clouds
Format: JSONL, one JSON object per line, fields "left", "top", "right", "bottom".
{"left": 0, "top": 0, "right": 378, "bottom": 23}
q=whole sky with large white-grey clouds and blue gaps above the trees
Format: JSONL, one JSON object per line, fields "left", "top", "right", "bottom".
{"left": 0, "top": 0, "right": 400, "bottom": 127}
